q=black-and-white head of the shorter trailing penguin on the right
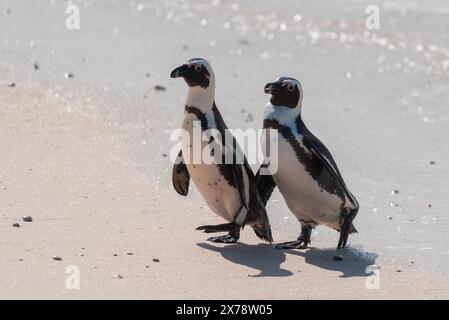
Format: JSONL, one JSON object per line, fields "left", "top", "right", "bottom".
{"left": 264, "top": 77, "right": 302, "bottom": 109}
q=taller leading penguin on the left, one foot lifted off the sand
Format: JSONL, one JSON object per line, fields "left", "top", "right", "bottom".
{"left": 170, "top": 58, "right": 273, "bottom": 243}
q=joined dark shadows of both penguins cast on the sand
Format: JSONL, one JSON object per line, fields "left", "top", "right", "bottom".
{"left": 197, "top": 243, "right": 377, "bottom": 278}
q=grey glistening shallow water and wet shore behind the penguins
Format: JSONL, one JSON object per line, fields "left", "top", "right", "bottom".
{"left": 0, "top": 0, "right": 449, "bottom": 273}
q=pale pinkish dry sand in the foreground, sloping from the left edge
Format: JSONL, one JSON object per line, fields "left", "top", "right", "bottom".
{"left": 0, "top": 86, "right": 449, "bottom": 299}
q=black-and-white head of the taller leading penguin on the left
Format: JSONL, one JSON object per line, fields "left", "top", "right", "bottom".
{"left": 170, "top": 58, "right": 214, "bottom": 89}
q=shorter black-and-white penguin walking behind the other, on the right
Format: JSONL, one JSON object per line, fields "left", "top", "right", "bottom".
{"left": 256, "top": 77, "right": 359, "bottom": 249}
